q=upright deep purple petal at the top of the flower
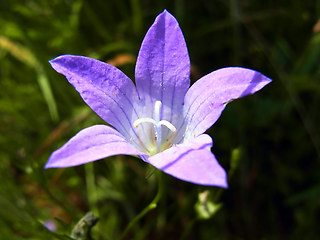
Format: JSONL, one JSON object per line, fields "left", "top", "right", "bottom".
{"left": 135, "top": 10, "right": 190, "bottom": 125}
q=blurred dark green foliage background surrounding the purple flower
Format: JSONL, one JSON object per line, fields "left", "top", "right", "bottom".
{"left": 0, "top": 0, "right": 320, "bottom": 240}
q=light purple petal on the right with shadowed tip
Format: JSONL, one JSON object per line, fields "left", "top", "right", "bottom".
{"left": 184, "top": 67, "right": 271, "bottom": 139}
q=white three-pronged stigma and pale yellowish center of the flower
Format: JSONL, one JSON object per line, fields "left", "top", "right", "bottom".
{"left": 133, "top": 101, "right": 177, "bottom": 156}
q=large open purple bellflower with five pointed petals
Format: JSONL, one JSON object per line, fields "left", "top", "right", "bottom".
{"left": 45, "top": 11, "right": 271, "bottom": 187}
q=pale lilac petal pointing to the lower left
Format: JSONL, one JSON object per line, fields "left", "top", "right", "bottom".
{"left": 45, "top": 125, "right": 145, "bottom": 168}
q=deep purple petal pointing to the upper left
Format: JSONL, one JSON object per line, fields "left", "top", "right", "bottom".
{"left": 50, "top": 55, "right": 139, "bottom": 139}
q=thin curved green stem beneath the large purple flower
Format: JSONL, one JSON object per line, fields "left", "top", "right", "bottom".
{"left": 119, "top": 170, "right": 163, "bottom": 240}
